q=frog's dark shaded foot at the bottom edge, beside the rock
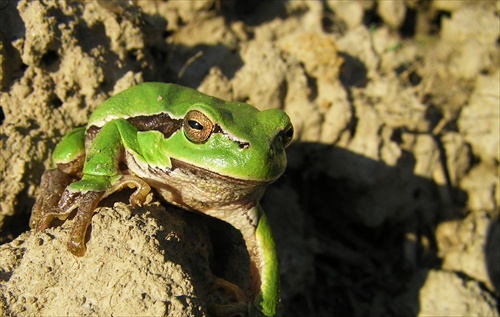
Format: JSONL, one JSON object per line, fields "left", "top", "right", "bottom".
{"left": 209, "top": 278, "right": 250, "bottom": 317}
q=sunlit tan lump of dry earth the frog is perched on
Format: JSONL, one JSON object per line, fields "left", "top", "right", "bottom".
{"left": 0, "top": 203, "right": 213, "bottom": 316}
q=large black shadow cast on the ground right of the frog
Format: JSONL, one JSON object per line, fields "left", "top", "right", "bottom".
{"left": 277, "top": 144, "right": 474, "bottom": 316}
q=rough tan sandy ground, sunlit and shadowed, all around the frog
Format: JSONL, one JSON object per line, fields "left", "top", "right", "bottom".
{"left": 0, "top": 0, "right": 500, "bottom": 316}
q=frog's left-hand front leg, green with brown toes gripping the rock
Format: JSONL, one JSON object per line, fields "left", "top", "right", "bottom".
{"left": 33, "top": 119, "right": 150, "bottom": 256}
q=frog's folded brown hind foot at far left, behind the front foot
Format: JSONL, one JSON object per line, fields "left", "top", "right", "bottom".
{"left": 30, "top": 168, "right": 73, "bottom": 232}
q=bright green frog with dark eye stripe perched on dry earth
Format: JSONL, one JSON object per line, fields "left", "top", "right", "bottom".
{"left": 29, "top": 82, "right": 294, "bottom": 316}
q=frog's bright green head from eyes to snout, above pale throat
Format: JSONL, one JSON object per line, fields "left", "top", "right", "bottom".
{"left": 172, "top": 98, "right": 293, "bottom": 181}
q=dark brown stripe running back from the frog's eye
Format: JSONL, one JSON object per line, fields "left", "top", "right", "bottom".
{"left": 127, "top": 113, "right": 182, "bottom": 139}
